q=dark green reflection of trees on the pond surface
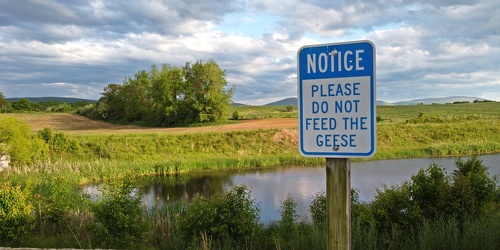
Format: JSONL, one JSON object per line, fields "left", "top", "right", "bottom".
{"left": 137, "top": 171, "right": 233, "bottom": 203}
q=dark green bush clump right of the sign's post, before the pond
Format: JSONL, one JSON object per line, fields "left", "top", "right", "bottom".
{"left": 369, "top": 157, "right": 497, "bottom": 235}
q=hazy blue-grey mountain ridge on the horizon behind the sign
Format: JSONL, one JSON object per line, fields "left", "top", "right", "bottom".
{"left": 263, "top": 96, "right": 488, "bottom": 106}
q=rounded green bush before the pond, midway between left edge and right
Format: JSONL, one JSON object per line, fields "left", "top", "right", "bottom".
{"left": 180, "top": 185, "right": 260, "bottom": 247}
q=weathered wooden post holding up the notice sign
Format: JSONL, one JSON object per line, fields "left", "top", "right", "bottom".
{"left": 326, "top": 158, "right": 351, "bottom": 250}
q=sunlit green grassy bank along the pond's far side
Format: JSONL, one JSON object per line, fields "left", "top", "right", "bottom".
{"left": 3, "top": 103, "right": 500, "bottom": 186}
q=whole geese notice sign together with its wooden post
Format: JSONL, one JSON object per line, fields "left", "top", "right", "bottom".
{"left": 297, "top": 41, "right": 376, "bottom": 249}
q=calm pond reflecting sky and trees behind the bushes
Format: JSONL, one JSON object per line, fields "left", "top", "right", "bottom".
{"left": 87, "top": 154, "right": 500, "bottom": 223}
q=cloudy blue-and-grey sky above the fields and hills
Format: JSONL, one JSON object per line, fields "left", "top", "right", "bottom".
{"left": 0, "top": 0, "right": 500, "bottom": 105}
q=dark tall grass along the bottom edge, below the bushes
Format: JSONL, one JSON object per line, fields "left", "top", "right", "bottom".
{"left": 4, "top": 203, "right": 500, "bottom": 250}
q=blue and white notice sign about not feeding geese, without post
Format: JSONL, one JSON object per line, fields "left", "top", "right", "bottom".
{"left": 297, "top": 41, "right": 377, "bottom": 158}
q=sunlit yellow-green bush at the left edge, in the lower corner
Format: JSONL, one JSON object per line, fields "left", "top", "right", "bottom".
{"left": 0, "top": 182, "right": 33, "bottom": 241}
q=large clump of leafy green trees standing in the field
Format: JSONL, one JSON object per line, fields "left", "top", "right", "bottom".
{"left": 78, "top": 60, "right": 234, "bottom": 126}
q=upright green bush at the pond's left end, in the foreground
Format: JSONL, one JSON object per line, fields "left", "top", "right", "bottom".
{"left": 92, "top": 181, "right": 145, "bottom": 248}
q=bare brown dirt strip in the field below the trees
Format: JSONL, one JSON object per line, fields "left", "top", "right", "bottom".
{"left": 12, "top": 114, "right": 298, "bottom": 136}
